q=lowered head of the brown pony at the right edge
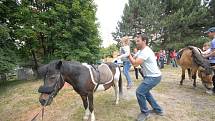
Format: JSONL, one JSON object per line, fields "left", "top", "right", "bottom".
{"left": 198, "top": 67, "right": 214, "bottom": 90}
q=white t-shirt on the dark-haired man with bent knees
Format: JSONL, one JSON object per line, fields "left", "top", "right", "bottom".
{"left": 136, "top": 46, "right": 161, "bottom": 77}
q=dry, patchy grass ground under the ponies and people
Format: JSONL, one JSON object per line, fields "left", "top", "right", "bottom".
{"left": 0, "top": 66, "right": 215, "bottom": 121}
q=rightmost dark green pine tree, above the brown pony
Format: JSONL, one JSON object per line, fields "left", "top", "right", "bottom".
{"left": 161, "top": 0, "right": 212, "bottom": 48}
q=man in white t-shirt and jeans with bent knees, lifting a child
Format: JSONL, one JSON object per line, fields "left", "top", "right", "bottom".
{"left": 129, "top": 34, "right": 163, "bottom": 121}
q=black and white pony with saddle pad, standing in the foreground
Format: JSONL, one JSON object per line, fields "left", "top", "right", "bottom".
{"left": 38, "top": 61, "right": 122, "bottom": 121}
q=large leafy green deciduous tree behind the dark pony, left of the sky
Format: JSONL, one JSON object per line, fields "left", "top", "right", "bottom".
{"left": 0, "top": 0, "right": 101, "bottom": 76}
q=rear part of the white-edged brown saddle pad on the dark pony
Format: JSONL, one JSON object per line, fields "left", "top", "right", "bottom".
{"left": 96, "top": 64, "right": 113, "bottom": 84}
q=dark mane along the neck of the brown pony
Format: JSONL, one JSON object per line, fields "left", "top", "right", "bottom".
{"left": 188, "top": 46, "right": 213, "bottom": 74}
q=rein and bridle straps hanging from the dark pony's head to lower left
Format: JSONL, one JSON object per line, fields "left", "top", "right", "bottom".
{"left": 31, "top": 73, "right": 64, "bottom": 121}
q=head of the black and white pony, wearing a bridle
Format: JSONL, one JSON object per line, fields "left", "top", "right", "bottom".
{"left": 38, "top": 61, "right": 65, "bottom": 106}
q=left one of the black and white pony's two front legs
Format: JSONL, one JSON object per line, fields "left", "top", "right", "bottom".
{"left": 81, "top": 96, "right": 90, "bottom": 120}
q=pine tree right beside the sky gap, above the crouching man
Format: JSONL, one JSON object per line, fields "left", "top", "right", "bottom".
{"left": 113, "top": 0, "right": 165, "bottom": 44}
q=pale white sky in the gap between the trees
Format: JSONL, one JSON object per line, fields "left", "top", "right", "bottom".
{"left": 95, "top": 0, "right": 128, "bottom": 47}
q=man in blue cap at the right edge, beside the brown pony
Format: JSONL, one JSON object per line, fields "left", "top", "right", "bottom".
{"left": 203, "top": 27, "right": 215, "bottom": 93}
